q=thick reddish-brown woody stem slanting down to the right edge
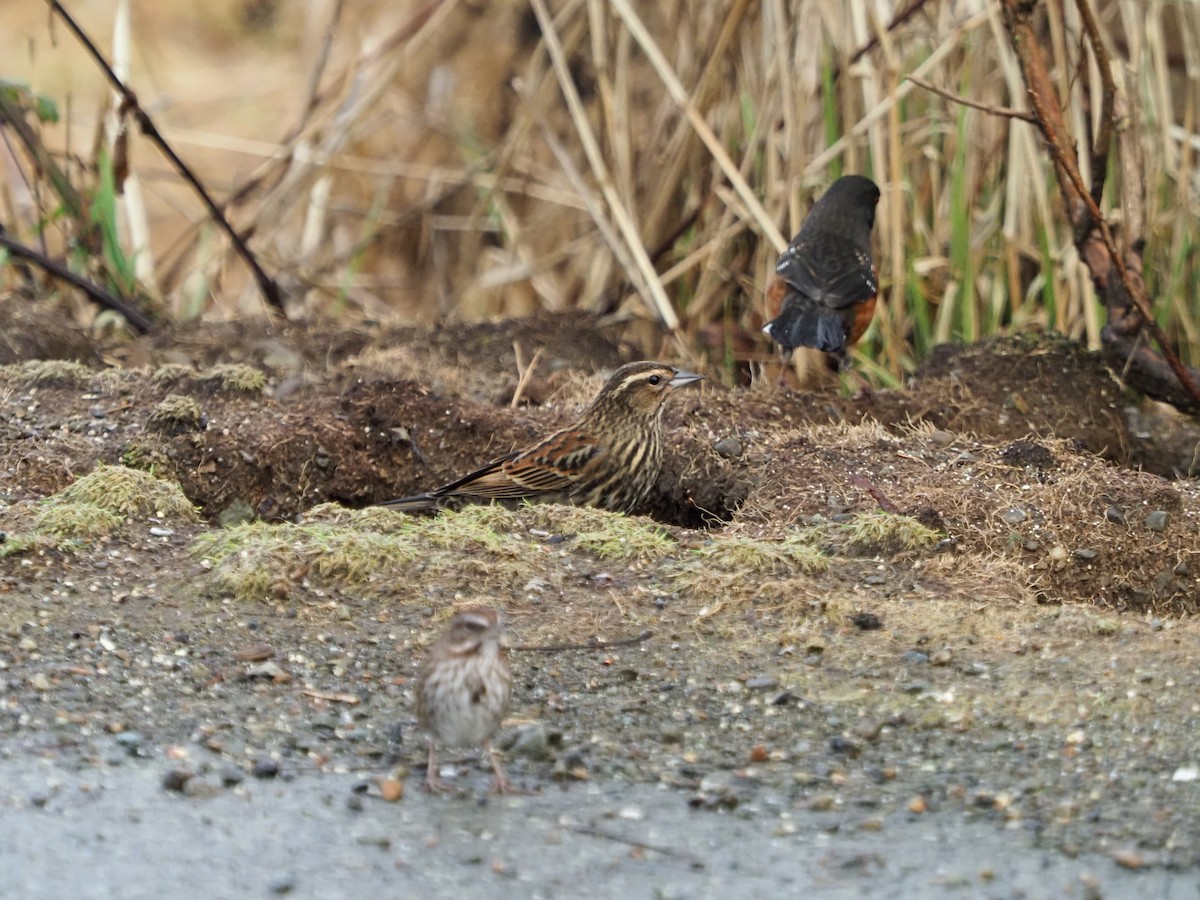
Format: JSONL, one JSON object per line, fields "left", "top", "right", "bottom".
{"left": 1002, "top": 0, "right": 1200, "bottom": 407}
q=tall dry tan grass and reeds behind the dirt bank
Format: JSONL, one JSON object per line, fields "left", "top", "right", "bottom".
{"left": 0, "top": 0, "right": 1200, "bottom": 382}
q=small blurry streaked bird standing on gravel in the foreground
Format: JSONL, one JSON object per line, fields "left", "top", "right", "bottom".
{"left": 416, "top": 606, "right": 512, "bottom": 793}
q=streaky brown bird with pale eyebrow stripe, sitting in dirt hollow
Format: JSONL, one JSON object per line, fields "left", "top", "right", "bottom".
{"left": 379, "top": 362, "right": 703, "bottom": 512}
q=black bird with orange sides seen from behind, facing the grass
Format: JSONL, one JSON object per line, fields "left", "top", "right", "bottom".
{"left": 762, "top": 175, "right": 880, "bottom": 368}
